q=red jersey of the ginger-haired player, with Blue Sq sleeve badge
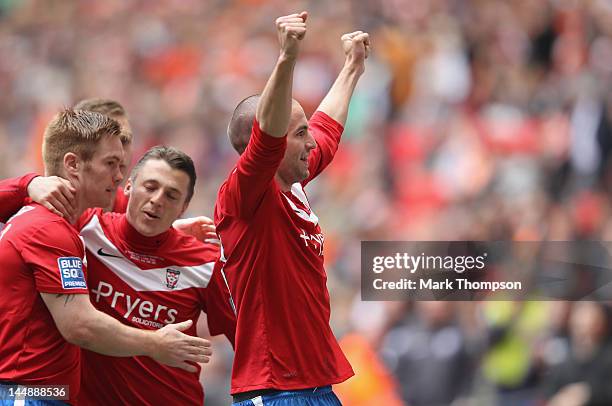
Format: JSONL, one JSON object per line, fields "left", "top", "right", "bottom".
{"left": 0, "top": 203, "right": 88, "bottom": 401}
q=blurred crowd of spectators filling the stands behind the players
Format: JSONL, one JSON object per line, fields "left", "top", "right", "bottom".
{"left": 0, "top": 0, "right": 612, "bottom": 406}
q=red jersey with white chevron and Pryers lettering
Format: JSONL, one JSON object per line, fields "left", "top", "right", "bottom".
{"left": 79, "top": 209, "right": 235, "bottom": 405}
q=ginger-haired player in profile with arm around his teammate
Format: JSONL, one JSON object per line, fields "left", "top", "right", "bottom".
{"left": 0, "top": 109, "right": 211, "bottom": 401}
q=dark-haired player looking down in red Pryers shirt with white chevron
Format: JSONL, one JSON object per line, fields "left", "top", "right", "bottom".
{"left": 79, "top": 147, "right": 235, "bottom": 405}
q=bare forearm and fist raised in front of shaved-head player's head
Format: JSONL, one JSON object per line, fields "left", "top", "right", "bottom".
{"left": 255, "top": 11, "right": 308, "bottom": 138}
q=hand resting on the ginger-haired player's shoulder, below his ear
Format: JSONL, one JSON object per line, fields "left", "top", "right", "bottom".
{"left": 28, "top": 176, "right": 76, "bottom": 220}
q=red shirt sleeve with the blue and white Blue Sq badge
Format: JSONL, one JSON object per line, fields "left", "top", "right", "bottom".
{"left": 20, "top": 220, "right": 88, "bottom": 294}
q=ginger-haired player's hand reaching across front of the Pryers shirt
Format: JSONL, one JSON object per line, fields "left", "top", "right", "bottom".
{"left": 151, "top": 320, "right": 212, "bottom": 372}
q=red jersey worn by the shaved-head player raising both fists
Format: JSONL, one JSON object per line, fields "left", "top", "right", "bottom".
{"left": 215, "top": 111, "right": 354, "bottom": 394}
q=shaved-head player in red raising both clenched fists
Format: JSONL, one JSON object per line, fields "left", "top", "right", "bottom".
{"left": 215, "top": 12, "right": 370, "bottom": 406}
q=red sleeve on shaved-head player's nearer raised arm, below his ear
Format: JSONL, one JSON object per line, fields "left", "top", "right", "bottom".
{"left": 220, "top": 120, "right": 287, "bottom": 218}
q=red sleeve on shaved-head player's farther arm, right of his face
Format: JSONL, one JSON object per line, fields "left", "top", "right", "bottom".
{"left": 302, "top": 110, "right": 344, "bottom": 186}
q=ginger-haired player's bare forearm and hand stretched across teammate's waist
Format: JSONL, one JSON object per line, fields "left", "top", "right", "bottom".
{"left": 41, "top": 293, "right": 211, "bottom": 372}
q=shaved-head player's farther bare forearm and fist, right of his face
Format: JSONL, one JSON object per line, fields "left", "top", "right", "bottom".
{"left": 317, "top": 31, "right": 370, "bottom": 126}
